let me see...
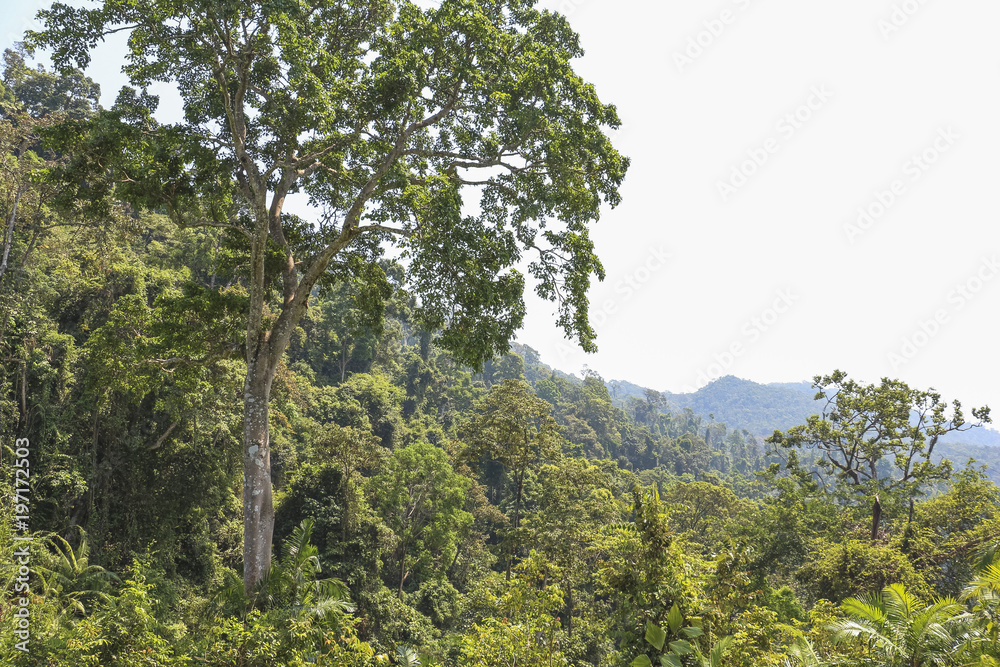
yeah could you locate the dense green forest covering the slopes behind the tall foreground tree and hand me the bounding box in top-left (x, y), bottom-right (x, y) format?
top-left (0, 3), bottom-right (1000, 667)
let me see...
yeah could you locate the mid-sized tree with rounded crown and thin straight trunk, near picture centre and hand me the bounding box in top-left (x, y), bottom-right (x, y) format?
top-left (465, 380), bottom-right (560, 580)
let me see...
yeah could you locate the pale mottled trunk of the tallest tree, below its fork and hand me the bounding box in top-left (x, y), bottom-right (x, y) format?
top-left (243, 360), bottom-right (274, 595)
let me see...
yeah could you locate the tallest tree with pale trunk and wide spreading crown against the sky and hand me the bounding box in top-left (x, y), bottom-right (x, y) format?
top-left (29, 0), bottom-right (628, 592)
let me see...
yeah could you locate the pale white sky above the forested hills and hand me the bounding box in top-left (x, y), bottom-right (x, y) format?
top-left (7, 0), bottom-right (1000, 421)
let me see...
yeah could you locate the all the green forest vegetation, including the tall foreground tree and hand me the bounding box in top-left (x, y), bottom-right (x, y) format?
top-left (0, 0), bottom-right (1000, 667)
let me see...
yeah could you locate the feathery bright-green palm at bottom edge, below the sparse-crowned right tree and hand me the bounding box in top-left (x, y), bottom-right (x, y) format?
top-left (830, 584), bottom-right (980, 667)
